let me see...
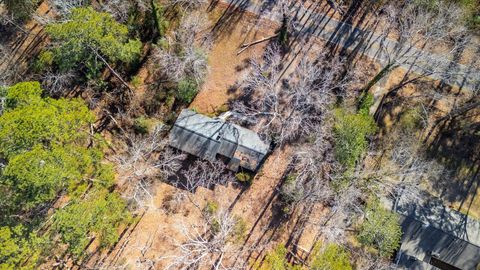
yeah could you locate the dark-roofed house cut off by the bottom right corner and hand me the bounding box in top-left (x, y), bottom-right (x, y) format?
top-left (396, 196), bottom-right (480, 270)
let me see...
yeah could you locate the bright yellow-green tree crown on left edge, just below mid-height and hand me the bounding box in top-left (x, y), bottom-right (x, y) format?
top-left (0, 144), bottom-right (101, 210)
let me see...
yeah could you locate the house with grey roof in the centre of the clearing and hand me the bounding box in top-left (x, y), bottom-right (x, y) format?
top-left (170, 109), bottom-right (270, 171)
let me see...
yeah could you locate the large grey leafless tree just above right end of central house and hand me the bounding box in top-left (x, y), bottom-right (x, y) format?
top-left (233, 46), bottom-right (346, 144)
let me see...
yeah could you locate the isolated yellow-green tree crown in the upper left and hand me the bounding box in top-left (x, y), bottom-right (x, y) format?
top-left (46, 7), bottom-right (141, 78)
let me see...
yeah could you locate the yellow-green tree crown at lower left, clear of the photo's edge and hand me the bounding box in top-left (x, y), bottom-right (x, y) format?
top-left (52, 191), bottom-right (132, 258)
